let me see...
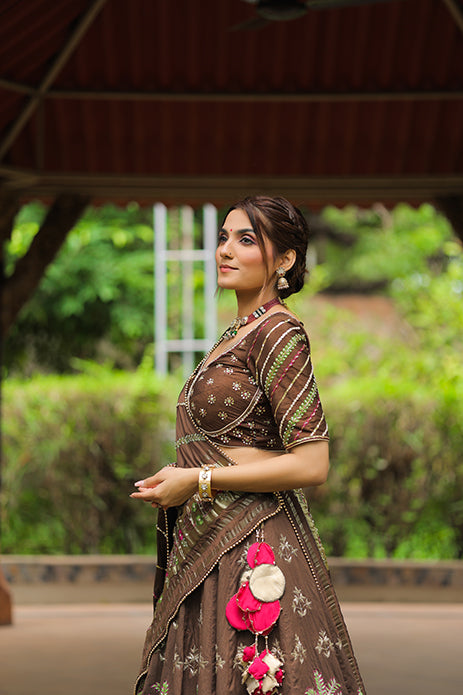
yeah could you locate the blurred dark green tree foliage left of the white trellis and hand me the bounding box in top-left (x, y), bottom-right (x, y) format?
top-left (5, 204), bottom-right (154, 373)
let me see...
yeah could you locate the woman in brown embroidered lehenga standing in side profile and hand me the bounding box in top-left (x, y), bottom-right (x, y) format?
top-left (132, 196), bottom-right (365, 695)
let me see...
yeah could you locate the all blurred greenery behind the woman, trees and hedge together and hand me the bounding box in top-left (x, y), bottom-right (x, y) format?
top-left (0, 203), bottom-right (463, 559)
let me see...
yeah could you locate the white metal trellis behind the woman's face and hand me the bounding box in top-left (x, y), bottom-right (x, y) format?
top-left (154, 203), bottom-right (217, 376)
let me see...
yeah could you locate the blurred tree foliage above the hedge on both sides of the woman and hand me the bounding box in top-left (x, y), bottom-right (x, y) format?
top-left (4, 198), bottom-right (462, 374)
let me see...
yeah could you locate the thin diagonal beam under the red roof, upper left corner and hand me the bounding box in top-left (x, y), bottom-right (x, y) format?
top-left (0, 0), bottom-right (106, 161)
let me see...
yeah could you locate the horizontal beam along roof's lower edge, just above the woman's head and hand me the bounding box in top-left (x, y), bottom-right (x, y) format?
top-left (0, 171), bottom-right (463, 204)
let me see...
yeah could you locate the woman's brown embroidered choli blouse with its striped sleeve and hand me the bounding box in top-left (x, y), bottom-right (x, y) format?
top-left (185, 312), bottom-right (328, 451)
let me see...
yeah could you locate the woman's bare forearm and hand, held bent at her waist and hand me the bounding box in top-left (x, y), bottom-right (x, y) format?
top-left (131, 441), bottom-right (329, 507)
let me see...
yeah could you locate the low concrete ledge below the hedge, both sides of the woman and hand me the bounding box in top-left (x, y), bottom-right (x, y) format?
top-left (0, 555), bottom-right (463, 603)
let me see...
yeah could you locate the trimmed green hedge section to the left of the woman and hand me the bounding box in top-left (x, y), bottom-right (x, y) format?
top-left (1, 366), bottom-right (177, 553)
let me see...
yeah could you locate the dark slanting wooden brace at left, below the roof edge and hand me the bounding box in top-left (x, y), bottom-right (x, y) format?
top-left (1, 193), bottom-right (90, 336)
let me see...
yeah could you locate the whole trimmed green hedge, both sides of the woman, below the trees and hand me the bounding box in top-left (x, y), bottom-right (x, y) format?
top-left (1, 367), bottom-right (463, 558)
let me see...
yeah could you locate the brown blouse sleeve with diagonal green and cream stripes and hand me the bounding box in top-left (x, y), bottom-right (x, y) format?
top-left (248, 312), bottom-right (329, 449)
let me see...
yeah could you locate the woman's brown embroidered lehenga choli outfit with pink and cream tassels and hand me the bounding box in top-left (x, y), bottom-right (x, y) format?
top-left (135, 311), bottom-right (366, 695)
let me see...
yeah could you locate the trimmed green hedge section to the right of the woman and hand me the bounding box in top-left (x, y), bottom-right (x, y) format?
top-left (309, 375), bottom-right (463, 559)
